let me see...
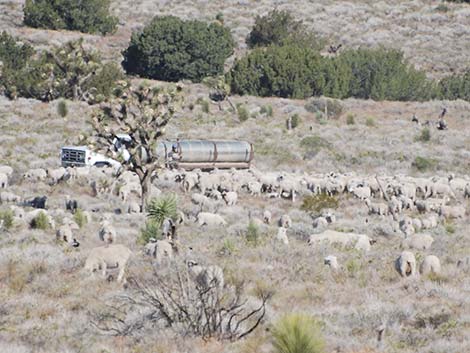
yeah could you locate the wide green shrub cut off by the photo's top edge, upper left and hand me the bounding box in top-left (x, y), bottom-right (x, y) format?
top-left (23, 0), bottom-right (118, 34)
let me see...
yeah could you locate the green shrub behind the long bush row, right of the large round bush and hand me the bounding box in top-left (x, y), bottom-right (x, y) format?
top-left (246, 9), bottom-right (325, 51)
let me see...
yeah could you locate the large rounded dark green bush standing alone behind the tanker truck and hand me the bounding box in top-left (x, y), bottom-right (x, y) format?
top-left (122, 16), bottom-right (234, 82)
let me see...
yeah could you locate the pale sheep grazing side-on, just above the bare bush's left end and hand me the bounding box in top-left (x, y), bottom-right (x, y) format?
top-left (85, 244), bottom-right (132, 282)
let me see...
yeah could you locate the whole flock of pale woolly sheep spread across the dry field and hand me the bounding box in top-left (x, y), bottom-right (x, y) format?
top-left (0, 161), bottom-right (470, 286)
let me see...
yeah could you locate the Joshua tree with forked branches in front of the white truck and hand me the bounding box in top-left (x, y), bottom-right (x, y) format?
top-left (91, 82), bottom-right (182, 212)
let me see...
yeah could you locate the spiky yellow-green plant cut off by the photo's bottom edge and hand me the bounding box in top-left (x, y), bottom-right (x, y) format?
top-left (272, 314), bottom-right (325, 353)
